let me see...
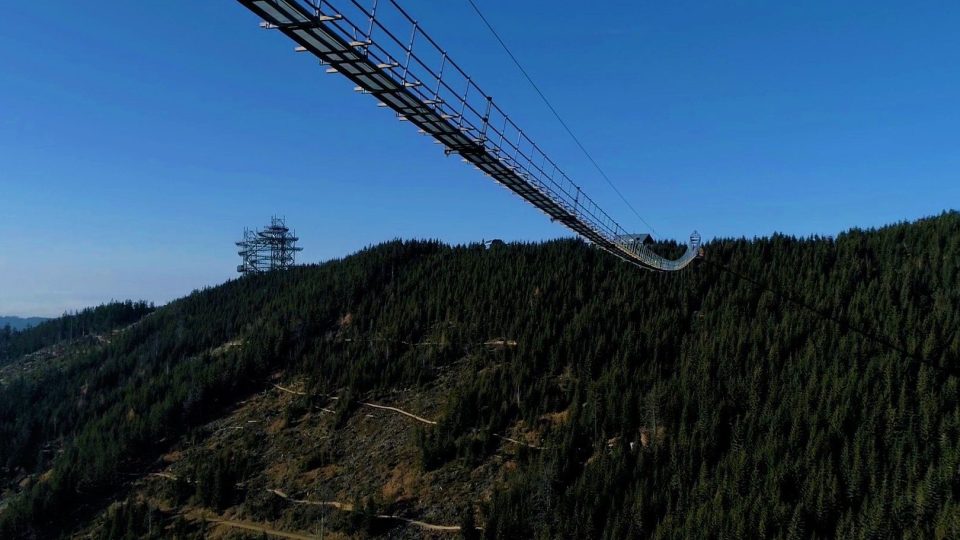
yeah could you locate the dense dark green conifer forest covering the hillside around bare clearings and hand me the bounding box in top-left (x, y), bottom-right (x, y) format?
top-left (0, 212), bottom-right (960, 539)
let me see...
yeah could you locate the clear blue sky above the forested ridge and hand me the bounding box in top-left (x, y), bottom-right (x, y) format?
top-left (0, 0), bottom-right (960, 315)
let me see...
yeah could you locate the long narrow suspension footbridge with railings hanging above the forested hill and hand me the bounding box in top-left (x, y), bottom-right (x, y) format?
top-left (238, 0), bottom-right (701, 271)
